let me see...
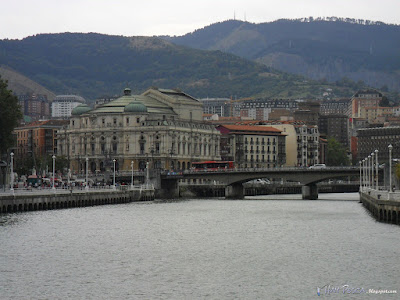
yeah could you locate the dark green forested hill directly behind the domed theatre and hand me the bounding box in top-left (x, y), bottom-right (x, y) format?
top-left (0, 33), bottom-right (364, 99)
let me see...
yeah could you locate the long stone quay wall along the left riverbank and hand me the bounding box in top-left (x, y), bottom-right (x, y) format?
top-left (0, 185), bottom-right (154, 213)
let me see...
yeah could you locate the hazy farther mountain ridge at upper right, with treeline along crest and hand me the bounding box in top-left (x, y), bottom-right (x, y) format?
top-left (164, 17), bottom-right (400, 91)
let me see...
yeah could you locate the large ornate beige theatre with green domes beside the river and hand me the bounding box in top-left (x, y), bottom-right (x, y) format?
top-left (58, 88), bottom-right (220, 173)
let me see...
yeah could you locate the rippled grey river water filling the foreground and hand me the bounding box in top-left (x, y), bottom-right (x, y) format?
top-left (0, 193), bottom-right (400, 299)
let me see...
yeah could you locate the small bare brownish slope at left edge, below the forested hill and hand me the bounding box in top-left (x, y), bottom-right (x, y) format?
top-left (0, 65), bottom-right (56, 101)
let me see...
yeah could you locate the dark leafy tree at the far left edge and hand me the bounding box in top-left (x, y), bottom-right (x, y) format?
top-left (0, 76), bottom-right (22, 155)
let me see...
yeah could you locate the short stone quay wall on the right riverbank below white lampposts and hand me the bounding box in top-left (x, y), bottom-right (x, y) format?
top-left (360, 188), bottom-right (400, 225)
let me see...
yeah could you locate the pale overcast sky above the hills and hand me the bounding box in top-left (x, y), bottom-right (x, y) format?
top-left (0, 0), bottom-right (400, 39)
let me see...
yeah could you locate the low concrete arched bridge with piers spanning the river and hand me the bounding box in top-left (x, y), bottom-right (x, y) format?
top-left (160, 167), bottom-right (360, 200)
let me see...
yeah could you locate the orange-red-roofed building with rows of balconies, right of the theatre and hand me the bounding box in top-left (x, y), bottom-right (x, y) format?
top-left (217, 125), bottom-right (286, 168)
